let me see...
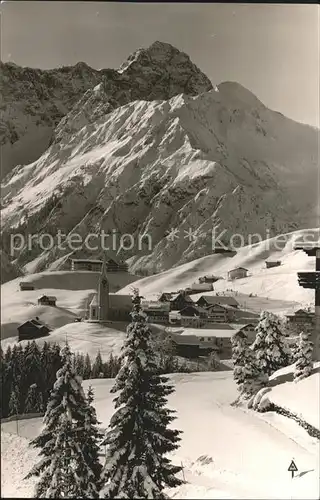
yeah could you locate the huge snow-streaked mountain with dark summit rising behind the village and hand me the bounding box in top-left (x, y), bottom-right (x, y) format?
top-left (2, 42), bottom-right (319, 278)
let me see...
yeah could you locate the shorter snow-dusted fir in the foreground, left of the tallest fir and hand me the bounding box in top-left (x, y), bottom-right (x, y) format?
top-left (26, 345), bottom-right (99, 498)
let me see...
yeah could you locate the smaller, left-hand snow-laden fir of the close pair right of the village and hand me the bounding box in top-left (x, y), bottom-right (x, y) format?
top-left (232, 331), bottom-right (268, 397)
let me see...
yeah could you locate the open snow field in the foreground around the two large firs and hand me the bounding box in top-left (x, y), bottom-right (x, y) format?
top-left (2, 372), bottom-right (319, 500)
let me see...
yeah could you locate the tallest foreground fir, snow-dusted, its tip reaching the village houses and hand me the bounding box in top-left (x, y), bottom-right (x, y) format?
top-left (100, 290), bottom-right (182, 499)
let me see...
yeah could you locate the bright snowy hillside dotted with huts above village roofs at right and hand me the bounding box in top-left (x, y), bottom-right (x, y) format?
top-left (119, 229), bottom-right (320, 311)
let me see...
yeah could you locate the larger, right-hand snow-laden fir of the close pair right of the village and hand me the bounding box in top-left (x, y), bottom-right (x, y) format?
top-left (252, 311), bottom-right (291, 375)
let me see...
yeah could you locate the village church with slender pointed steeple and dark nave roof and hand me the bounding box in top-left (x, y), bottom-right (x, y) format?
top-left (87, 256), bottom-right (132, 323)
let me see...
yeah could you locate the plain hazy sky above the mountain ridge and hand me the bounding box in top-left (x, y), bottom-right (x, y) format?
top-left (1, 1), bottom-right (319, 126)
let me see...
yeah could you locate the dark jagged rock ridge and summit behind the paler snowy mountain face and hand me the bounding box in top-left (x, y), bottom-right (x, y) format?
top-left (0, 42), bottom-right (212, 175)
